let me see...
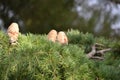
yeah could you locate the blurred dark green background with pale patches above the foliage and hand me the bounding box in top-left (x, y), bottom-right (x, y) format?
top-left (0, 0), bottom-right (120, 38)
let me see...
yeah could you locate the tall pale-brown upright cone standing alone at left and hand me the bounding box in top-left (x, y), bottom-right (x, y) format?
top-left (7, 23), bottom-right (19, 45)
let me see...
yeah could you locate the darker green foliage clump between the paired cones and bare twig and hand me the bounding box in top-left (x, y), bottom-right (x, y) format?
top-left (67, 30), bottom-right (95, 53)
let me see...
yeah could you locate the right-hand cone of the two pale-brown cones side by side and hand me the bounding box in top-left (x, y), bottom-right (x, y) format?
top-left (57, 31), bottom-right (68, 44)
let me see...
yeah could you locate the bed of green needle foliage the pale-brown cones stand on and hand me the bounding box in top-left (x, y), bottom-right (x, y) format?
top-left (0, 30), bottom-right (120, 80)
